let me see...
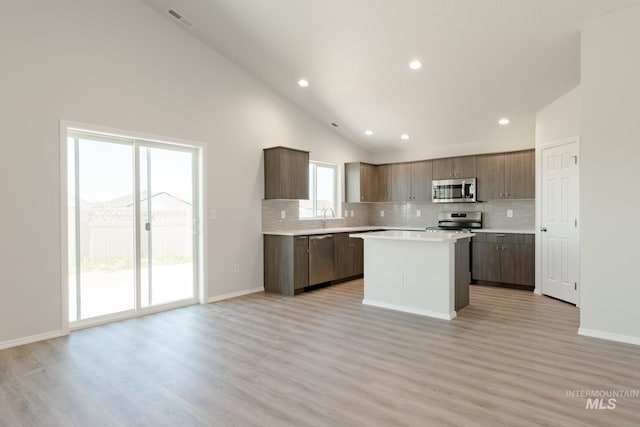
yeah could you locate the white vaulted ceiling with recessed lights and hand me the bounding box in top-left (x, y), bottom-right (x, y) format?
top-left (143, 0), bottom-right (640, 151)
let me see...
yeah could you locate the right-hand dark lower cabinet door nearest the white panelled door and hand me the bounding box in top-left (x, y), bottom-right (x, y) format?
top-left (500, 243), bottom-right (535, 286)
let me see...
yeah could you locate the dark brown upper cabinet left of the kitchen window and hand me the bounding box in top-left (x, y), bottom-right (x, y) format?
top-left (264, 147), bottom-right (309, 200)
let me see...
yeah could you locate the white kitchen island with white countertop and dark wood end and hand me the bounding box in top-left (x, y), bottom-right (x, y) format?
top-left (350, 230), bottom-right (475, 320)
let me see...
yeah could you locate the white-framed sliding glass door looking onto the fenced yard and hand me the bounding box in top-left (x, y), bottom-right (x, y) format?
top-left (67, 131), bottom-right (199, 327)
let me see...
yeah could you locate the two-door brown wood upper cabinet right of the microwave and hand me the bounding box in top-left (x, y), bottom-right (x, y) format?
top-left (476, 150), bottom-right (536, 201)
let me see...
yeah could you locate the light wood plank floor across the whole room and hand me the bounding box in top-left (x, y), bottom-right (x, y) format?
top-left (0, 280), bottom-right (640, 427)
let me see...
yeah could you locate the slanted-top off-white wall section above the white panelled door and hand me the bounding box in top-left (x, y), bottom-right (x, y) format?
top-left (536, 86), bottom-right (582, 147)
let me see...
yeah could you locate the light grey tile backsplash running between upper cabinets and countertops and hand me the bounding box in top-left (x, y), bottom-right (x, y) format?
top-left (262, 199), bottom-right (535, 231)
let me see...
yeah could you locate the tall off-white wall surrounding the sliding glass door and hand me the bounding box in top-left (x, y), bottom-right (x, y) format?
top-left (0, 0), bottom-right (367, 347)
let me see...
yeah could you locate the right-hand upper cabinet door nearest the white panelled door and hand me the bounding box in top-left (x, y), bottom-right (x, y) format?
top-left (504, 150), bottom-right (536, 199)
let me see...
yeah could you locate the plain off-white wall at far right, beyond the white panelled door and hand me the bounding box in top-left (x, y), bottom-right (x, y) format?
top-left (580, 2), bottom-right (640, 344)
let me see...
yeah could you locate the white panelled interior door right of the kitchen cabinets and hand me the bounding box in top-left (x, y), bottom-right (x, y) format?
top-left (540, 141), bottom-right (580, 304)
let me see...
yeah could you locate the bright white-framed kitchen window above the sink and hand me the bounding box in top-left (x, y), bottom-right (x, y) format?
top-left (299, 162), bottom-right (340, 218)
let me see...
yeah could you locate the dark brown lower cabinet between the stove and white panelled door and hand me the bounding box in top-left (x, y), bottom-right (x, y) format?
top-left (471, 233), bottom-right (535, 289)
